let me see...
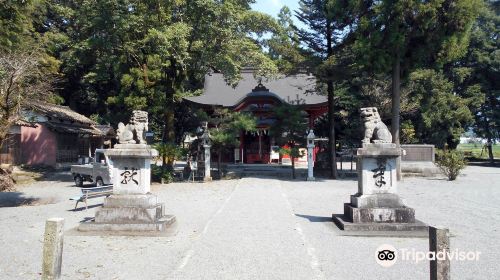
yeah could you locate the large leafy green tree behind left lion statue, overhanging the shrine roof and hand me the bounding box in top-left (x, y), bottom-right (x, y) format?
top-left (41, 0), bottom-right (277, 151)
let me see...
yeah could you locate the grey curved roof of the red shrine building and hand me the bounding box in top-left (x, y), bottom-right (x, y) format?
top-left (185, 70), bottom-right (328, 107)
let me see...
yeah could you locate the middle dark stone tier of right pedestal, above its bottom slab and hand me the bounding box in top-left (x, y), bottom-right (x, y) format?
top-left (344, 203), bottom-right (415, 223)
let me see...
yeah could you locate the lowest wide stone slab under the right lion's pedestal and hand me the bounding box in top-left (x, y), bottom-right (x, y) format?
top-left (332, 215), bottom-right (428, 237)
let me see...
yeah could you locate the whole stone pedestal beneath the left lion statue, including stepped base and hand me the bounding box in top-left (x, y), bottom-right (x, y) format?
top-left (78, 144), bottom-right (175, 232)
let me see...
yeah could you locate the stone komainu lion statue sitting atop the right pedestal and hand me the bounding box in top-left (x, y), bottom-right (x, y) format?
top-left (360, 107), bottom-right (392, 144)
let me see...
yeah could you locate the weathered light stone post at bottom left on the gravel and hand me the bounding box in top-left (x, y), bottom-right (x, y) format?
top-left (42, 218), bottom-right (64, 280)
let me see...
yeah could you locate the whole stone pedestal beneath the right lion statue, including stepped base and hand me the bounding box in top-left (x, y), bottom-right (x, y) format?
top-left (333, 143), bottom-right (427, 232)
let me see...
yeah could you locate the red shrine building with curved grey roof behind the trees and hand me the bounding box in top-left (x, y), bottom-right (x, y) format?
top-left (186, 70), bottom-right (328, 163)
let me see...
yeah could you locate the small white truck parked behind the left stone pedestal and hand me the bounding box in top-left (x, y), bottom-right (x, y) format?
top-left (71, 149), bottom-right (112, 188)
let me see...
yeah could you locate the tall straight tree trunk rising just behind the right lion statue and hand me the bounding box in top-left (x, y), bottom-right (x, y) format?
top-left (391, 53), bottom-right (401, 181)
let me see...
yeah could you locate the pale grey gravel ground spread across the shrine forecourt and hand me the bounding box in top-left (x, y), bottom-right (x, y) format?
top-left (0, 167), bottom-right (500, 279)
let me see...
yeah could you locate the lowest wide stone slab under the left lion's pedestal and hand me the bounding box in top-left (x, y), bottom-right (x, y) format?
top-left (78, 215), bottom-right (175, 233)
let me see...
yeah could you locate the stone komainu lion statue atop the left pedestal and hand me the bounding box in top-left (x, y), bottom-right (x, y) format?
top-left (116, 111), bottom-right (148, 144)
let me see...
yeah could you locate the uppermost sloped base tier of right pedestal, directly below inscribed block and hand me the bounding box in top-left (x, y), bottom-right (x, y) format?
top-left (351, 193), bottom-right (405, 208)
